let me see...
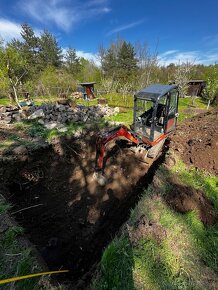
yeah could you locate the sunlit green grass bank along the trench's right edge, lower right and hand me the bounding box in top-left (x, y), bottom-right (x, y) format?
top-left (93, 161), bottom-right (218, 290)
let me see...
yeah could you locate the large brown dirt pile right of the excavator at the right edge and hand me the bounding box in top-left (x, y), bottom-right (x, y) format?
top-left (171, 109), bottom-right (218, 175)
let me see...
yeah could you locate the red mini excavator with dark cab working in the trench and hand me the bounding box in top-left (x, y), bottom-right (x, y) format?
top-left (94, 84), bottom-right (179, 185)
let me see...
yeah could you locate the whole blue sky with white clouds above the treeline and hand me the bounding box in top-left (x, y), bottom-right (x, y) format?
top-left (0, 0), bottom-right (218, 64)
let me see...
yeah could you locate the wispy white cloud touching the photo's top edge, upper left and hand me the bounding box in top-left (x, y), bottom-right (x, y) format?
top-left (19, 0), bottom-right (110, 31)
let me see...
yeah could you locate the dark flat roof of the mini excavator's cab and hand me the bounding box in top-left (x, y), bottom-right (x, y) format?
top-left (135, 84), bottom-right (177, 101)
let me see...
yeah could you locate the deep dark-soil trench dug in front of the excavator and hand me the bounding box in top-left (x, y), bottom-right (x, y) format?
top-left (0, 132), bottom-right (167, 289)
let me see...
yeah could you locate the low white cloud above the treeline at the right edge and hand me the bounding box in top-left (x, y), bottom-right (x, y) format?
top-left (158, 50), bottom-right (218, 66)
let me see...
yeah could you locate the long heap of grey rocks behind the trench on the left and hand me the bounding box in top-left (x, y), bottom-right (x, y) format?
top-left (0, 104), bottom-right (119, 126)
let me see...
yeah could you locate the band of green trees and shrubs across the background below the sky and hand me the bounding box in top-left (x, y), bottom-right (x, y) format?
top-left (0, 23), bottom-right (218, 103)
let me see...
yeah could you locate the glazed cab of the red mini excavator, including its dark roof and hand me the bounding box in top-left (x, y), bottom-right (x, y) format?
top-left (131, 84), bottom-right (179, 143)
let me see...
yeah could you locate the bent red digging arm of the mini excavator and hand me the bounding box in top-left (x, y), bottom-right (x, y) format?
top-left (95, 125), bottom-right (141, 172)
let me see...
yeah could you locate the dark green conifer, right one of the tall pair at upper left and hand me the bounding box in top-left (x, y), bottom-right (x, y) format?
top-left (39, 30), bottom-right (62, 69)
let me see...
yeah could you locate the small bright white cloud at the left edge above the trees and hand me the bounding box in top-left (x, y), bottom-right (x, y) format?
top-left (0, 18), bottom-right (21, 42)
